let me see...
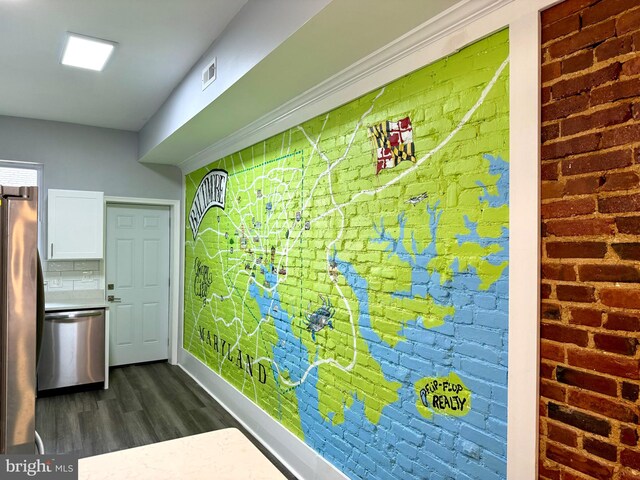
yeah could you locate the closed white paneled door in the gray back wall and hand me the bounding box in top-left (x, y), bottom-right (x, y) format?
top-left (106, 205), bottom-right (169, 366)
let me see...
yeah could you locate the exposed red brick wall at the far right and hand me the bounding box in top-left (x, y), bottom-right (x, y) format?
top-left (540, 0), bottom-right (640, 480)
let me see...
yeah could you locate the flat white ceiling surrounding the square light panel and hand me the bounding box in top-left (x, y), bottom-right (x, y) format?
top-left (0, 0), bottom-right (247, 131)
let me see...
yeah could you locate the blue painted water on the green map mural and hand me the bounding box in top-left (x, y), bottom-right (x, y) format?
top-left (250, 156), bottom-right (509, 480)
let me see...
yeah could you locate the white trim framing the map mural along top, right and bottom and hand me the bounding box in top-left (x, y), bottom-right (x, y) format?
top-left (180, 0), bottom-right (558, 480)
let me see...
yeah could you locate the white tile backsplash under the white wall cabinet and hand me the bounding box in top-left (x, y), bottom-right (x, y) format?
top-left (42, 260), bottom-right (104, 292)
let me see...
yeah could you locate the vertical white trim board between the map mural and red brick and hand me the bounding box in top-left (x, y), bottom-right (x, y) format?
top-left (507, 4), bottom-right (540, 479)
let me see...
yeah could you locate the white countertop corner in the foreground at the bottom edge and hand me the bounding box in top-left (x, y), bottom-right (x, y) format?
top-left (78, 428), bottom-right (285, 480)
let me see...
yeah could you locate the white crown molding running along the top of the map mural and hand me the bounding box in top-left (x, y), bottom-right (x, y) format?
top-left (177, 0), bottom-right (514, 174)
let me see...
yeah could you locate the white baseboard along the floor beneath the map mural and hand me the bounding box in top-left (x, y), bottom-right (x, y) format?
top-left (178, 348), bottom-right (348, 480)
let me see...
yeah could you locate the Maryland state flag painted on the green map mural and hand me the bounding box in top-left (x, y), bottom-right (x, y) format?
top-left (369, 117), bottom-right (416, 175)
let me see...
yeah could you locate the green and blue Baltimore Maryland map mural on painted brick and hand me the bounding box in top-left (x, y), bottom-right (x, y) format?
top-left (184, 30), bottom-right (509, 480)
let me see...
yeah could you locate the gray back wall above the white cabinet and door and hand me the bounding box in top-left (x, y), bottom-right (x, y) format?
top-left (0, 116), bottom-right (182, 200)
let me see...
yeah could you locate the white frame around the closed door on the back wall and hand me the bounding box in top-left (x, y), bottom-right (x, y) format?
top-left (104, 196), bottom-right (182, 365)
